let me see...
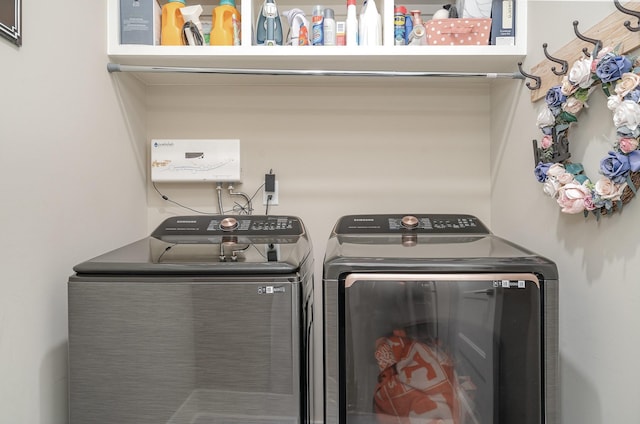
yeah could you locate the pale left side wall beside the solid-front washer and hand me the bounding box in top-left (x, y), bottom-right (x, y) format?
top-left (0, 1), bottom-right (147, 424)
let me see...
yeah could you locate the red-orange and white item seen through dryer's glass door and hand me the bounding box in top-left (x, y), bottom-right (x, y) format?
top-left (374, 330), bottom-right (459, 424)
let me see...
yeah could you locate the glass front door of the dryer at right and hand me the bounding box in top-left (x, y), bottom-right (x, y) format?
top-left (339, 274), bottom-right (543, 424)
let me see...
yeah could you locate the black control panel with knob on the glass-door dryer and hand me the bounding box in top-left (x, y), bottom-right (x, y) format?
top-left (335, 214), bottom-right (490, 235)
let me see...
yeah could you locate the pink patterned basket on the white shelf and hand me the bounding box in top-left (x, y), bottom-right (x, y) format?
top-left (424, 18), bottom-right (491, 46)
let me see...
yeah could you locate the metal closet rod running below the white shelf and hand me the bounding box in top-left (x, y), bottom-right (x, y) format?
top-left (107, 63), bottom-right (525, 80)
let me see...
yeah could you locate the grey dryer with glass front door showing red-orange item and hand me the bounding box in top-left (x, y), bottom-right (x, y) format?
top-left (323, 214), bottom-right (558, 424)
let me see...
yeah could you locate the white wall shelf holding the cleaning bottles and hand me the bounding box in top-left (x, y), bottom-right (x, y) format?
top-left (107, 0), bottom-right (527, 83)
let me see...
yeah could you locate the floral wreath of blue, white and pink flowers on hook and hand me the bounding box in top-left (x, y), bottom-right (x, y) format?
top-left (534, 46), bottom-right (640, 219)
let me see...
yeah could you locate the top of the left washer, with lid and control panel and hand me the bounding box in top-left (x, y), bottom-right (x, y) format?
top-left (74, 215), bottom-right (311, 275)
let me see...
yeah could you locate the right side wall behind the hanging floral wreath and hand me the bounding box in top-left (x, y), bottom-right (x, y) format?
top-left (491, 1), bottom-right (640, 424)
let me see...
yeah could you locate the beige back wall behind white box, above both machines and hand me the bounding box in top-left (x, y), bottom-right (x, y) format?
top-left (148, 81), bottom-right (490, 276)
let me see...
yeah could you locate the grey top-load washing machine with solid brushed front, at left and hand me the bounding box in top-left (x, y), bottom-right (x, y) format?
top-left (68, 215), bottom-right (313, 424)
